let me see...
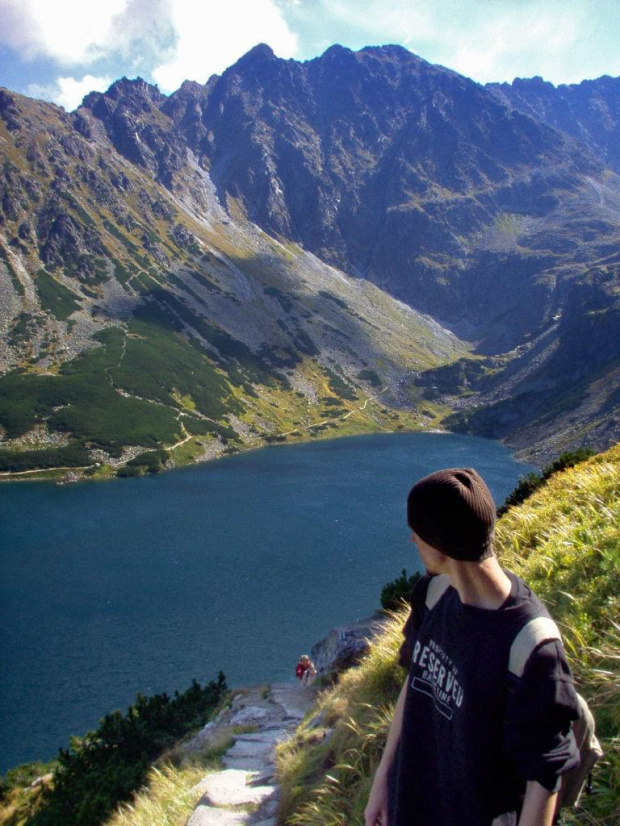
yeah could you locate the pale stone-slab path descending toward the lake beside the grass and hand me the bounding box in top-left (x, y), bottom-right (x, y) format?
top-left (187, 683), bottom-right (316, 826)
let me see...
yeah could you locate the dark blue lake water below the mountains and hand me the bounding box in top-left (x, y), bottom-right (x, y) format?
top-left (0, 434), bottom-right (530, 772)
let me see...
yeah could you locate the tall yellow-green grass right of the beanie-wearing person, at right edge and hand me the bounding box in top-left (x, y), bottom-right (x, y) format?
top-left (497, 446), bottom-right (620, 826)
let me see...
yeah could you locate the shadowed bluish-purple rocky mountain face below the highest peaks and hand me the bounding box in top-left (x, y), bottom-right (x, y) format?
top-left (164, 46), bottom-right (618, 334)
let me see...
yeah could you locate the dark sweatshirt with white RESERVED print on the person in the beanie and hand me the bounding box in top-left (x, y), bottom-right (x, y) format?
top-left (389, 572), bottom-right (579, 826)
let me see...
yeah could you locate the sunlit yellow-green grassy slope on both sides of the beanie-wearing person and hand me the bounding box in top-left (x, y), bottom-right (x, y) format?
top-left (280, 446), bottom-right (620, 826)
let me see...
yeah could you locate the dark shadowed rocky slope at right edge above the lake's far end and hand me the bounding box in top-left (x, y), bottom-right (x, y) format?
top-left (440, 256), bottom-right (620, 466)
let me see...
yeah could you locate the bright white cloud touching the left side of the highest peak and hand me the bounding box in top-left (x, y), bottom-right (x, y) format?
top-left (152, 0), bottom-right (297, 92)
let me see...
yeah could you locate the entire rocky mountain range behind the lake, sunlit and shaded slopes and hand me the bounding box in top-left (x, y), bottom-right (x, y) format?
top-left (0, 45), bottom-right (620, 475)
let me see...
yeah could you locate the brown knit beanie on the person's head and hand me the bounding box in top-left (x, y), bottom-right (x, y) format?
top-left (407, 468), bottom-right (495, 562)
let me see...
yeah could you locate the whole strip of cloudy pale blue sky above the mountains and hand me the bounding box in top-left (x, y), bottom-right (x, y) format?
top-left (0, 0), bottom-right (620, 111)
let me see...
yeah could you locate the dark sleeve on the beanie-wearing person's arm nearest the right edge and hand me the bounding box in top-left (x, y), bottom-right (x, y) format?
top-left (504, 641), bottom-right (579, 792)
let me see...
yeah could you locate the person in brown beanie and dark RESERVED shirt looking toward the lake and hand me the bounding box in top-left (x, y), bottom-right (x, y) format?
top-left (364, 468), bottom-right (579, 826)
